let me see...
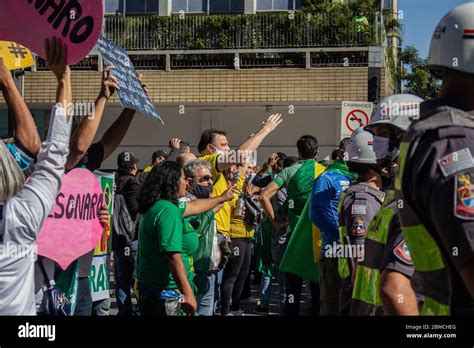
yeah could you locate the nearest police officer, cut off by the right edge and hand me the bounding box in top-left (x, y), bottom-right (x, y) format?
top-left (395, 2), bottom-right (474, 315)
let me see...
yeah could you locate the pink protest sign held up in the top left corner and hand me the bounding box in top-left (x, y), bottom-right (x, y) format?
top-left (0, 0), bottom-right (104, 64)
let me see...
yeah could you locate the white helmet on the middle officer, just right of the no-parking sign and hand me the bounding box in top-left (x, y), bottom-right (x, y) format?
top-left (365, 94), bottom-right (423, 131)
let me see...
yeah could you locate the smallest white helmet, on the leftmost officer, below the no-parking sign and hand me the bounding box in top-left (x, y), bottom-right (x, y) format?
top-left (347, 127), bottom-right (377, 164)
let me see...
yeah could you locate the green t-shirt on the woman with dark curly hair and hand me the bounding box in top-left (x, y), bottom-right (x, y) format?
top-left (137, 199), bottom-right (199, 289)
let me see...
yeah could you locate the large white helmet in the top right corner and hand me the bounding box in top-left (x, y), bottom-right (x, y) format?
top-left (428, 2), bottom-right (474, 77)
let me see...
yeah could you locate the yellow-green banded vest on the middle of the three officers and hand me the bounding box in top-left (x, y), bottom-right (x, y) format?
top-left (350, 190), bottom-right (398, 315)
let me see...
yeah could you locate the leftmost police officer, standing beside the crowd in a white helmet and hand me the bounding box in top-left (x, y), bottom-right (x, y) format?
top-left (338, 128), bottom-right (385, 314)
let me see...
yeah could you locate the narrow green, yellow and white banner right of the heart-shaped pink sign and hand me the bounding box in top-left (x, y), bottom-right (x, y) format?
top-left (89, 171), bottom-right (115, 301)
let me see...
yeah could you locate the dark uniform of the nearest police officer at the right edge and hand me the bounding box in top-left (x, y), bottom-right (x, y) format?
top-left (395, 100), bottom-right (474, 315)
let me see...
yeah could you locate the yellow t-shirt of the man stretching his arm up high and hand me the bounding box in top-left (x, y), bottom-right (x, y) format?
top-left (199, 153), bottom-right (230, 234)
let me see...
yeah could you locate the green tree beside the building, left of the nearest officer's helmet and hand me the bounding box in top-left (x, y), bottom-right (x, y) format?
top-left (399, 45), bottom-right (441, 100)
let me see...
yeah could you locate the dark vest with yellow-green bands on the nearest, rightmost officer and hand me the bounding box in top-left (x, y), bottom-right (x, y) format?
top-left (395, 109), bottom-right (474, 315)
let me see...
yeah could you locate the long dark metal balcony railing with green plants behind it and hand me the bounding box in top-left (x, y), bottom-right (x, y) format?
top-left (104, 11), bottom-right (380, 50)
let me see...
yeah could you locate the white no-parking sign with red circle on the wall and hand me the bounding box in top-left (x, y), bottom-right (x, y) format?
top-left (341, 101), bottom-right (374, 139)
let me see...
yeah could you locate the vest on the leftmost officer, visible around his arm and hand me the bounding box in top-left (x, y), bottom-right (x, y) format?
top-left (338, 184), bottom-right (385, 279)
